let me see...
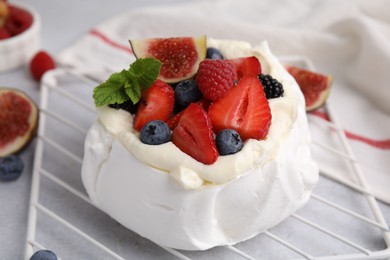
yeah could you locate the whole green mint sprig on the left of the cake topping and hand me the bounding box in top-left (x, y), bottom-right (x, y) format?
top-left (93, 58), bottom-right (161, 107)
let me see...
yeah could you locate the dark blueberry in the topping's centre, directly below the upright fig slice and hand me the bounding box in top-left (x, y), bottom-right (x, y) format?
top-left (175, 79), bottom-right (202, 107)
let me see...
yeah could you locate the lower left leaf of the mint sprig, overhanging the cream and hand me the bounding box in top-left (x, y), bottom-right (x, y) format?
top-left (93, 70), bottom-right (129, 107)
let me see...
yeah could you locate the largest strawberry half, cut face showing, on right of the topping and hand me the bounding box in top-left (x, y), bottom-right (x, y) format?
top-left (208, 75), bottom-right (271, 140)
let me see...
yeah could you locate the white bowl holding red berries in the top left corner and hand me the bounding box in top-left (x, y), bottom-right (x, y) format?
top-left (0, 3), bottom-right (41, 72)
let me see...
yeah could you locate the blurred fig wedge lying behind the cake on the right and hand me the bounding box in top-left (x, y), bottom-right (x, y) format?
top-left (285, 65), bottom-right (332, 112)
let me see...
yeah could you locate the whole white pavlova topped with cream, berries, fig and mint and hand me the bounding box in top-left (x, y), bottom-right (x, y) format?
top-left (82, 37), bottom-right (318, 250)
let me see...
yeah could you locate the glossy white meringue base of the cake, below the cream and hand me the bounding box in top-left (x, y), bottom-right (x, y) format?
top-left (82, 109), bottom-right (318, 250)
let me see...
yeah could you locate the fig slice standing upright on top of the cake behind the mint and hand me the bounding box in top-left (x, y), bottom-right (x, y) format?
top-left (129, 35), bottom-right (207, 83)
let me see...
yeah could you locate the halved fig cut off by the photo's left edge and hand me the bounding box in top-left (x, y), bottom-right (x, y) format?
top-left (0, 87), bottom-right (39, 157)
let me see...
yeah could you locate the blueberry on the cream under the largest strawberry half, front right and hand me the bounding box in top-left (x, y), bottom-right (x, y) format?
top-left (216, 129), bottom-right (243, 155)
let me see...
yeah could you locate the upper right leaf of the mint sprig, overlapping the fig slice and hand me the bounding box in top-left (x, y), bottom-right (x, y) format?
top-left (129, 58), bottom-right (161, 90)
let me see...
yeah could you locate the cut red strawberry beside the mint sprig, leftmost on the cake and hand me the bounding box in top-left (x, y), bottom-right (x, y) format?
top-left (134, 79), bottom-right (175, 131)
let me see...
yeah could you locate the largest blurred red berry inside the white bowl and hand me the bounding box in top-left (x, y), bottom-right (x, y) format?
top-left (5, 5), bottom-right (33, 35)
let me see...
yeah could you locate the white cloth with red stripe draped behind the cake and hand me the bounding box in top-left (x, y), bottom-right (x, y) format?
top-left (58, 0), bottom-right (390, 203)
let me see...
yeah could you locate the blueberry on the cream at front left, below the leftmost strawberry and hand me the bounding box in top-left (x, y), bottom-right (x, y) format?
top-left (140, 120), bottom-right (171, 145)
